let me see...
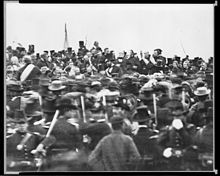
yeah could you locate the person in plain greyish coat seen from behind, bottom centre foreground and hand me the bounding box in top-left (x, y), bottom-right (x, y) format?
top-left (88, 116), bottom-right (140, 171)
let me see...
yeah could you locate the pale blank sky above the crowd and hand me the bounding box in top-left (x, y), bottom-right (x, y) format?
top-left (5, 2), bottom-right (214, 60)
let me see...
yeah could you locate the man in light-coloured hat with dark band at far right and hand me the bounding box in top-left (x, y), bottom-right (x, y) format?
top-left (187, 87), bottom-right (211, 127)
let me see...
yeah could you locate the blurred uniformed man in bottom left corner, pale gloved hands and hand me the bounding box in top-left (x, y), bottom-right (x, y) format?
top-left (6, 110), bottom-right (55, 172)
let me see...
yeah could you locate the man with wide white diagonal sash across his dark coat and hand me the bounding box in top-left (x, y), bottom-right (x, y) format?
top-left (16, 56), bottom-right (41, 82)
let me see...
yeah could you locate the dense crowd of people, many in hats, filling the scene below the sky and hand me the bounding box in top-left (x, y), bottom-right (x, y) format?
top-left (6, 41), bottom-right (214, 171)
